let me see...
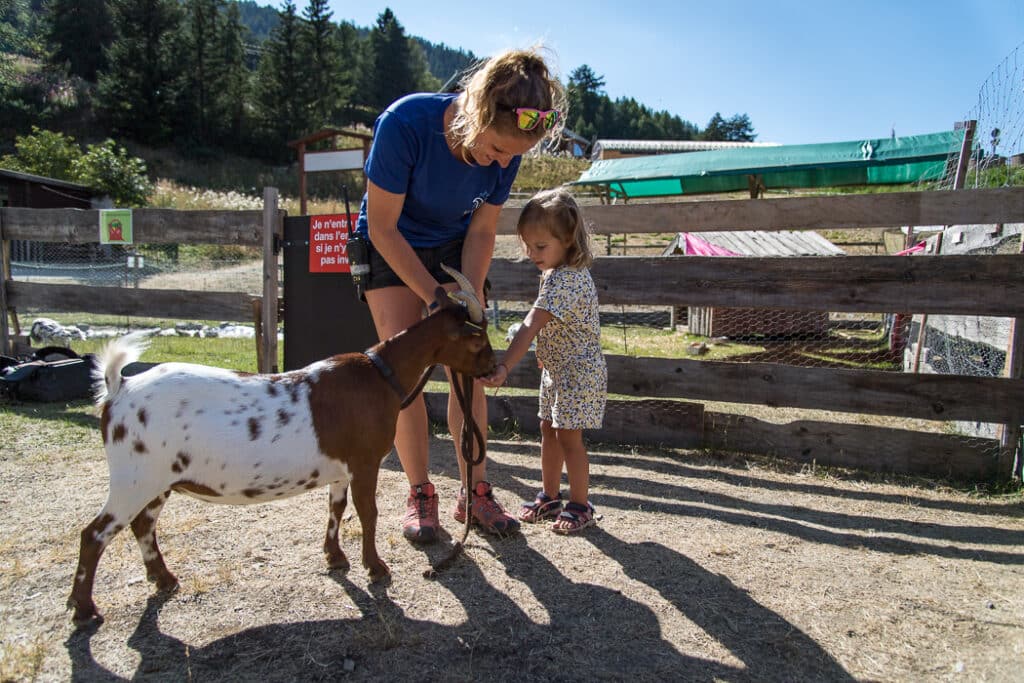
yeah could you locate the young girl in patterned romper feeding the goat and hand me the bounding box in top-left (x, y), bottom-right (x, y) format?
top-left (481, 189), bottom-right (608, 533)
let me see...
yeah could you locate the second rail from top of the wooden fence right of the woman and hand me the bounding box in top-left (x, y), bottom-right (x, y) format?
top-left (487, 254), bottom-right (1024, 317)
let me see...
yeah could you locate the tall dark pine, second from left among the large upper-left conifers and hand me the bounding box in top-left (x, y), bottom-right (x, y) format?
top-left (97, 0), bottom-right (184, 142)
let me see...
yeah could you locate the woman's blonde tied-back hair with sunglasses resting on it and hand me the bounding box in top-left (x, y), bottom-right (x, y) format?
top-left (451, 48), bottom-right (566, 147)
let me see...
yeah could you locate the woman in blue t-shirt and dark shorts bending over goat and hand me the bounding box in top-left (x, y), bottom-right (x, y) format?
top-left (357, 49), bottom-right (564, 543)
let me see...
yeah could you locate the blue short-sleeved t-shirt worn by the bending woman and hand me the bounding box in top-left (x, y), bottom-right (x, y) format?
top-left (356, 93), bottom-right (521, 247)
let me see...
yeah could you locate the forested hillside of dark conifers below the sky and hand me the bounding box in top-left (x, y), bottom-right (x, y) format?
top-left (0, 0), bottom-right (756, 169)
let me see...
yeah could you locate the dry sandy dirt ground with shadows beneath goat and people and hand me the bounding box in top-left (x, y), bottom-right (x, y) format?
top-left (0, 428), bottom-right (1024, 682)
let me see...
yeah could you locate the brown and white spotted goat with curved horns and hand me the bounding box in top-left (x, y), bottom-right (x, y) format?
top-left (68, 278), bottom-right (495, 625)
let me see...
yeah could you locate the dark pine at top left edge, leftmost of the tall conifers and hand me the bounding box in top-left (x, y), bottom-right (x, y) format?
top-left (45, 0), bottom-right (114, 83)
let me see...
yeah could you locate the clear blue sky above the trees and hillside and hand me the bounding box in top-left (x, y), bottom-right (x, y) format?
top-left (329, 0), bottom-right (1024, 144)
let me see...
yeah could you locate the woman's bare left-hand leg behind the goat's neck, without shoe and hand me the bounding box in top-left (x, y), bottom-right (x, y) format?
top-left (367, 287), bottom-right (430, 486)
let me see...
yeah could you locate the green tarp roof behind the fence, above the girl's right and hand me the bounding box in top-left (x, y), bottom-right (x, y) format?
top-left (570, 130), bottom-right (964, 198)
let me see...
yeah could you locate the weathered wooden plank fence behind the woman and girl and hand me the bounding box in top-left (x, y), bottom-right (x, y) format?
top-left (0, 188), bottom-right (1024, 479)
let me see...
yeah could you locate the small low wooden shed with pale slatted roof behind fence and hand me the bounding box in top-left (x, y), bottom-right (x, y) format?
top-left (663, 230), bottom-right (845, 338)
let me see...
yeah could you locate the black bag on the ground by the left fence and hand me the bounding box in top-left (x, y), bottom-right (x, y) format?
top-left (0, 347), bottom-right (95, 401)
